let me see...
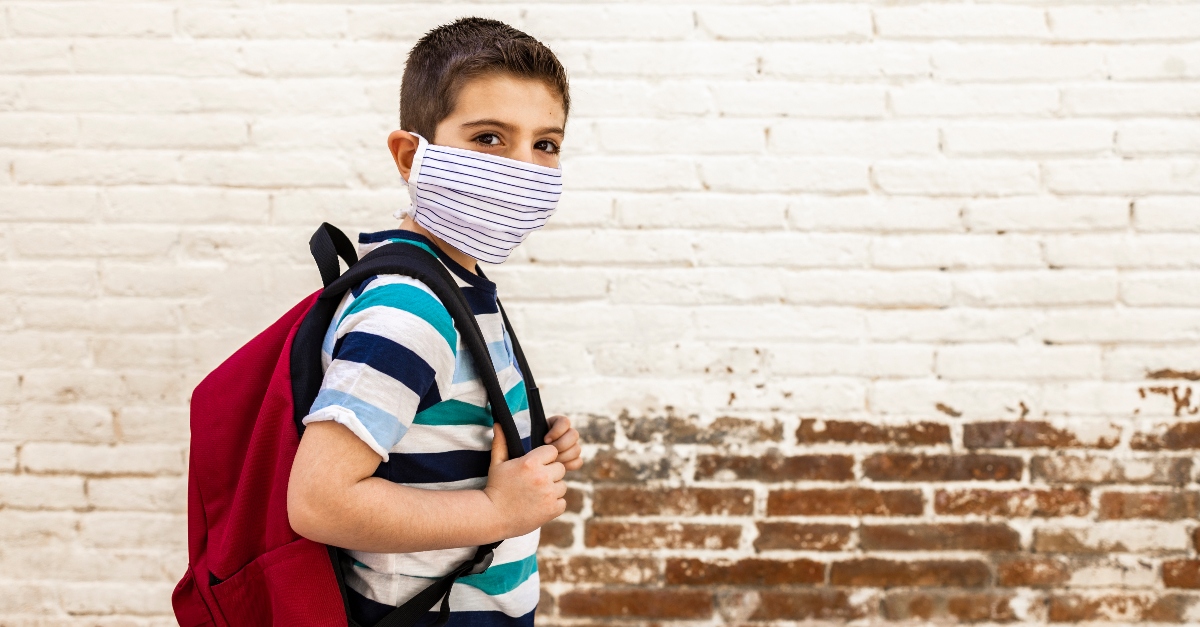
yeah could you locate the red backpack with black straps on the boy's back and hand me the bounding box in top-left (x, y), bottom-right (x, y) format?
top-left (172, 223), bottom-right (547, 627)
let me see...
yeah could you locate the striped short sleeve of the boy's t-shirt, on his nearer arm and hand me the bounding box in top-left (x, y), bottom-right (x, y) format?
top-left (302, 275), bottom-right (458, 461)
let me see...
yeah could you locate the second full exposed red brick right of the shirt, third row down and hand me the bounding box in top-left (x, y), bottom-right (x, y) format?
top-left (767, 488), bottom-right (925, 516)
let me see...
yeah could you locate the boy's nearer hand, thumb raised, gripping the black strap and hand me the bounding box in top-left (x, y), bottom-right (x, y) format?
top-left (484, 424), bottom-right (566, 538)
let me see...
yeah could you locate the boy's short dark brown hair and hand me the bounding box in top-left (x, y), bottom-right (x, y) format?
top-left (400, 17), bottom-right (571, 142)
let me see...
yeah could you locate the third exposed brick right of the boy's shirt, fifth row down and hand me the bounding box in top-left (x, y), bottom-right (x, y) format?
top-left (829, 559), bottom-right (989, 587)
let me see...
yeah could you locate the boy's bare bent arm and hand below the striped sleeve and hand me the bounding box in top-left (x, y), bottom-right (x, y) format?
top-left (288, 422), bottom-right (566, 553)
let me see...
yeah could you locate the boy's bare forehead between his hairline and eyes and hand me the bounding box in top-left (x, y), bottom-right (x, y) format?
top-left (443, 73), bottom-right (566, 132)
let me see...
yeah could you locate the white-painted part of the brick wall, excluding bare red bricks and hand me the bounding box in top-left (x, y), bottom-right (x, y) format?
top-left (0, 0), bottom-right (1200, 627)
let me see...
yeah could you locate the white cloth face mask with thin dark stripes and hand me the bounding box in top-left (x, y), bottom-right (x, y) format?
top-left (397, 133), bottom-right (563, 263)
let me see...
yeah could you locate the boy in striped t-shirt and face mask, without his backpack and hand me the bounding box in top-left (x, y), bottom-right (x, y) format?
top-left (288, 18), bottom-right (582, 626)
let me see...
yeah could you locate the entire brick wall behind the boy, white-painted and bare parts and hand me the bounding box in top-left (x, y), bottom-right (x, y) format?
top-left (0, 0), bottom-right (1200, 627)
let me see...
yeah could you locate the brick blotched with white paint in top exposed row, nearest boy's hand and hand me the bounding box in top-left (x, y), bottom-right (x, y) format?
top-left (620, 414), bottom-right (784, 444)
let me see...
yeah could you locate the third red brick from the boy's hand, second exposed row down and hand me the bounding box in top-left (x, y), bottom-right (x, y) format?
top-left (863, 453), bottom-right (1022, 482)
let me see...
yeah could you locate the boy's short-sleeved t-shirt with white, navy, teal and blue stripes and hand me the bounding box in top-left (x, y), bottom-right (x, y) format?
top-left (304, 231), bottom-right (539, 627)
